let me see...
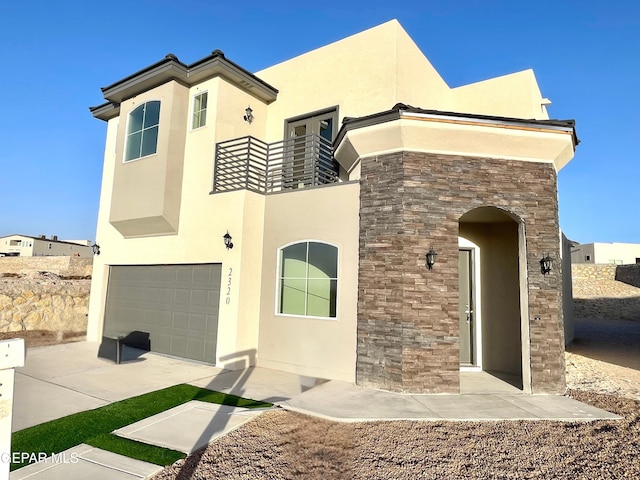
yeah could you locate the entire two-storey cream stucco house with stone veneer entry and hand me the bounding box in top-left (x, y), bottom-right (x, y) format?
top-left (88, 21), bottom-right (577, 393)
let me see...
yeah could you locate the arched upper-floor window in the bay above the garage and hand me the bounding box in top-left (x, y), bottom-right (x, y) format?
top-left (124, 100), bottom-right (160, 162)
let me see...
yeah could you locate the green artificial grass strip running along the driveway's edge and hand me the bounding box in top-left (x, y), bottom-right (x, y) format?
top-left (11, 383), bottom-right (272, 470)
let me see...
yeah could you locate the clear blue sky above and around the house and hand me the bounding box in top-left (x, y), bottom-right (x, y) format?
top-left (0, 0), bottom-right (640, 243)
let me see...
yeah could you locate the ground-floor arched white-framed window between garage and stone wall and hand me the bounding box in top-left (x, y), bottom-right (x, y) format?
top-left (278, 241), bottom-right (338, 318)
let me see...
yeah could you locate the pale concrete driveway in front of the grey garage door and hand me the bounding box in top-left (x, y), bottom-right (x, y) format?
top-left (12, 342), bottom-right (306, 432)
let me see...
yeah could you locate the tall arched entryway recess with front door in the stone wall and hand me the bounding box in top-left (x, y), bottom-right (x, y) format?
top-left (459, 207), bottom-right (530, 393)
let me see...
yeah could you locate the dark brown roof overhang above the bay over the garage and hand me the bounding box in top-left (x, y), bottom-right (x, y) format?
top-left (89, 50), bottom-right (278, 120)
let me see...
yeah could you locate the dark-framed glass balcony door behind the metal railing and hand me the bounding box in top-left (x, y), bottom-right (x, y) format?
top-left (283, 109), bottom-right (338, 188)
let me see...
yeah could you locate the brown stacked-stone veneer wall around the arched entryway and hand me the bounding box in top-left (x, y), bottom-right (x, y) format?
top-left (356, 152), bottom-right (565, 393)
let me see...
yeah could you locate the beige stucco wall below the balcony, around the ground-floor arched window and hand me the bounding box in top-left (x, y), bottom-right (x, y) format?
top-left (258, 183), bottom-right (359, 382)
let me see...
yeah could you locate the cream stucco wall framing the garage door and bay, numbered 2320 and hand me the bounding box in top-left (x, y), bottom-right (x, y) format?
top-left (87, 79), bottom-right (264, 366)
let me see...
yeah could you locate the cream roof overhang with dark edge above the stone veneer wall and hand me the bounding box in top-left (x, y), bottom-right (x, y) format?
top-left (335, 105), bottom-right (579, 171)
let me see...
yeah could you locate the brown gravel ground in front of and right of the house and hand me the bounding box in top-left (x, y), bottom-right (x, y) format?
top-left (154, 316), bottom-right (640, 480)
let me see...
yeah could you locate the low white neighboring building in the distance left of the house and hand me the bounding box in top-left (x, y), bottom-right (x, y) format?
top-left (0, 235), bottom-right (93, 257)
